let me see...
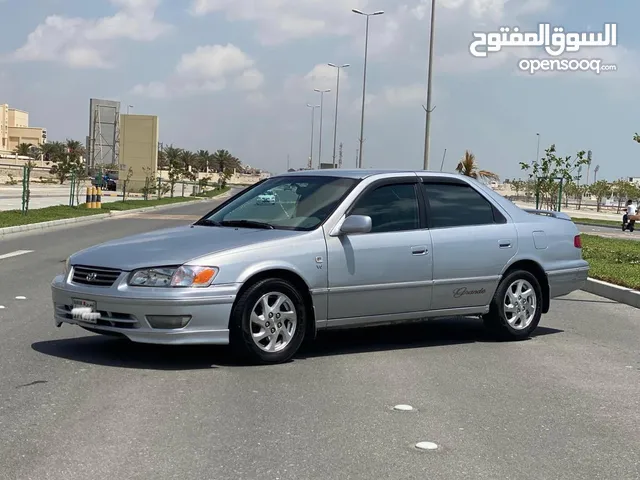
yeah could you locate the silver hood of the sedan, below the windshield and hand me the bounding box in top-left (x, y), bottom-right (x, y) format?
top-left (71, 225), bottom-right (305, 271)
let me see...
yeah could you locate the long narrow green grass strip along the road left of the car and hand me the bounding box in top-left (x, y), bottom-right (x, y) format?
top-left (0, 197), bottom-right (195, 228)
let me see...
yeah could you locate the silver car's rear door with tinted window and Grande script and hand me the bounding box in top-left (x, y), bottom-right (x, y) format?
top-left (422, 177), bottom-right (518, 310)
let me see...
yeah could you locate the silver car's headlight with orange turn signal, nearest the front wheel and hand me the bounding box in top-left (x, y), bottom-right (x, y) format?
top-left (129, 265), bottom-right (218, 287)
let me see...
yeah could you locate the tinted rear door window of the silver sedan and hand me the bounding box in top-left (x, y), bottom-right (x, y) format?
top-left (424, 183), bottom-right (494, 228)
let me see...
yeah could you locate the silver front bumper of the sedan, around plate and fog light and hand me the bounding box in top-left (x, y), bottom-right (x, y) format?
top-left (51, 275), bottom-right (240, 345)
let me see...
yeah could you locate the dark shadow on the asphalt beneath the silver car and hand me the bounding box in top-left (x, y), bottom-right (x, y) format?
top-left (31, 318), bottom-right (562, 371)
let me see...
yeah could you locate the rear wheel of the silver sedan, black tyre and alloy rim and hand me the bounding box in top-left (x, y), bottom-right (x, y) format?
top-left (483, 270), bottom-right (543, 340)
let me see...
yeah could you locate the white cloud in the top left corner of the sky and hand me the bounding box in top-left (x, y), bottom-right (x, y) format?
top-left (11, 0), bottom-right (171, 68)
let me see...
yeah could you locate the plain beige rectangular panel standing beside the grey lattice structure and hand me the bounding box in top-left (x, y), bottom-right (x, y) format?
top-left (118, 115), bottom-right (158, 192)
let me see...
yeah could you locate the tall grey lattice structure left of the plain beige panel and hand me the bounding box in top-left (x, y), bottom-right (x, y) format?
top-left (86, 98), bottom-right (120, 173)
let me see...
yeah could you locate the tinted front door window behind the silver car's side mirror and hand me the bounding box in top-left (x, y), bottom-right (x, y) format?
top-left (350, 184), bottom-right (420, 233)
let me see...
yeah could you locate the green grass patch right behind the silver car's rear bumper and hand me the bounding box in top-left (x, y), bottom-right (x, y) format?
top-left (581, 234), bottom-right (640, 290)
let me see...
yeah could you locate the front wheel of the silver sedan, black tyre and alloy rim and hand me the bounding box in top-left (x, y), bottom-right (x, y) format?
top-left (229, 278), bottom-right (307, 364)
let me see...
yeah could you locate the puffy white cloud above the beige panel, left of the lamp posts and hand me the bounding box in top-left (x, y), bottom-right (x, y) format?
top-left (132, 44), bottom-right (264, 98)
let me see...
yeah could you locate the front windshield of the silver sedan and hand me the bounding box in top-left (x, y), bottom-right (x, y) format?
top-left (197, 175), bottom-right (357, 230)
